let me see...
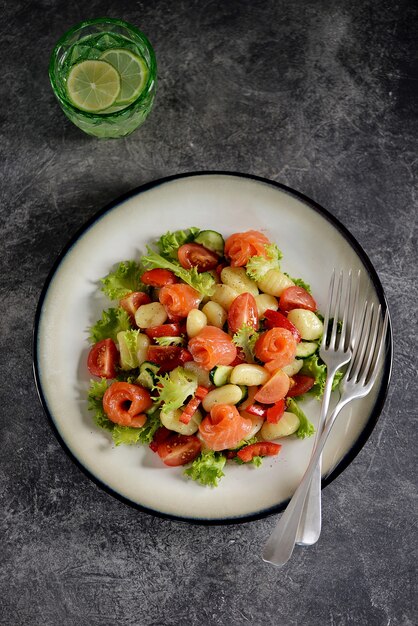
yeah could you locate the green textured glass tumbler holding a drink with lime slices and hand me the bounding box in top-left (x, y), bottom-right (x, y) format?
top-left (49, 17), bottom-right (157, 138)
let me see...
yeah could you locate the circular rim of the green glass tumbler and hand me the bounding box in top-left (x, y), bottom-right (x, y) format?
top-left (48, 17), bottom-right (157, 120)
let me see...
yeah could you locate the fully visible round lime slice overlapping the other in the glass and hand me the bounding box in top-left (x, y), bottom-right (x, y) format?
top-left (67, 61), bottom-right (121, 113)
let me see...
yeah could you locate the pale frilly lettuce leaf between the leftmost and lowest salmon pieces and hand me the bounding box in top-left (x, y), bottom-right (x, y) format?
top-left (153, 367), bottom-right (197, 415)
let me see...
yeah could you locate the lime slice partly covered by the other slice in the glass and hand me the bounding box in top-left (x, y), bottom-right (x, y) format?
top-left (100, 48), bottom-right (148, 105)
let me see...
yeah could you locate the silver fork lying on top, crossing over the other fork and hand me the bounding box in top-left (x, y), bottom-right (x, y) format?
top-left (263, 301), bottom-right (389, 567)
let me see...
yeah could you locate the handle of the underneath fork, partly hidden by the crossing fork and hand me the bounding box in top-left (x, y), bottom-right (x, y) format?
top-left (296, 368), bottom-right (337, 546)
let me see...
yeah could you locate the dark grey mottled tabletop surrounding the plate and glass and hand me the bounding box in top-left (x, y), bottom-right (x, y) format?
top-left (0, 0), bottom-right (418, 626)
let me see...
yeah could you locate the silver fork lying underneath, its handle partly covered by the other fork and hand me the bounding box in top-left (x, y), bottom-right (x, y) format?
top-left (296, 269), bottom-right (360, 545)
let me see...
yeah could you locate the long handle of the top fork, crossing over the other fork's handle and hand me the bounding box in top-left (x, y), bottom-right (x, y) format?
top-left (263, 400), bottom-right (349, 567)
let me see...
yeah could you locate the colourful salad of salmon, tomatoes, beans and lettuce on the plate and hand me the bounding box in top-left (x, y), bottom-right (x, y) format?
top-left (87, 227), bottom-right (340, 486)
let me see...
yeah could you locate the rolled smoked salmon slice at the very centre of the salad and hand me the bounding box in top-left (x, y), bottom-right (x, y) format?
top-left (188, 326), bottom-right (237, 370)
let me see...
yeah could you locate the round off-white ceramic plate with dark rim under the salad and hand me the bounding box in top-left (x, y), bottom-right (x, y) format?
top-left (34, 172), bottom-right (392, 523)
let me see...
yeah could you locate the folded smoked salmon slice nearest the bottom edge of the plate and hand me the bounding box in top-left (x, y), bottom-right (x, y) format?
top-left (199, 404), bottom-right (252, 452)
